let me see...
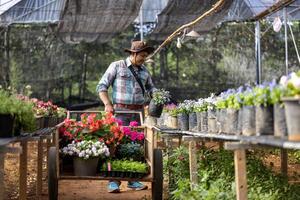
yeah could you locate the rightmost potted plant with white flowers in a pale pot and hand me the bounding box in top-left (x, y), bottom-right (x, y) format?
top-left (281, 71), bottom-right (300, 141)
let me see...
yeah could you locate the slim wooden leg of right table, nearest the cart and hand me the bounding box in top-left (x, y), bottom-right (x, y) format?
top-left (189, 141), bottom-right (198, 189)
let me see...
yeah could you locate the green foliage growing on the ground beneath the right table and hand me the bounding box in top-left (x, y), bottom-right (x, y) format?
top-left (165, 147), bottom-right (300, 200)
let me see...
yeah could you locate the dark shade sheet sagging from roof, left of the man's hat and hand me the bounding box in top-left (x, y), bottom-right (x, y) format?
top-left (58, 0), bottom-right (142, 43)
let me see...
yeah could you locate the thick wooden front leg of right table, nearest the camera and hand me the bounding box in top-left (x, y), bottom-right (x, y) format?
top-left (234, 149), bottom-right (247, 200)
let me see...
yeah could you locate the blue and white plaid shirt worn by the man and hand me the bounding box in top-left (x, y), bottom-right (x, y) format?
top-left (96, 57), bottom-right (155, 105)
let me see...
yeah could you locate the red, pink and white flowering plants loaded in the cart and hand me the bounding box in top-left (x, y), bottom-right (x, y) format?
top-left (59, 113), bottom-right (145, 176)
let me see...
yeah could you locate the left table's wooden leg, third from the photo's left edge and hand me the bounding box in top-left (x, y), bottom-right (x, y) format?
top-left (36, 137), bottom-right (43, 199)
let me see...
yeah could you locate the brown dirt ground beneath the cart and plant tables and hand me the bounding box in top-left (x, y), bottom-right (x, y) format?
top-left (4, 142), bottom-right (300, 200)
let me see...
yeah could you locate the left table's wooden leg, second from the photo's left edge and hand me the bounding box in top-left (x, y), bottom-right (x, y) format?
top-left (19, 141), bottom-right (27, 200)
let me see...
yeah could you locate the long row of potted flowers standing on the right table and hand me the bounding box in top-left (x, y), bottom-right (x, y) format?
top-left (158, 72), bottom-right (300, 140)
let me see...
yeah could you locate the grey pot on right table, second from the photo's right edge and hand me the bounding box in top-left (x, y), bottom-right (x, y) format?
top-left (274, 104), bottom-right (287, 138)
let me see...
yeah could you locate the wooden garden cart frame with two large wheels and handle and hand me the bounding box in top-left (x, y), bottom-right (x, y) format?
top-left (48, 111), bottom-right (163, 200)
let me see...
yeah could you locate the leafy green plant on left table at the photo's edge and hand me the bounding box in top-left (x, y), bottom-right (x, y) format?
top-left (0, 89), bottom-right (35, 131)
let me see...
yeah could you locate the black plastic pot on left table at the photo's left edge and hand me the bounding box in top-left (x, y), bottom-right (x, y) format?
top-left (0, 114), bottom-right (15, 138)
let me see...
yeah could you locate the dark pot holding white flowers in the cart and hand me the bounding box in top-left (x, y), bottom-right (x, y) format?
top-left (73, 157), bottom-right (99, 176)
